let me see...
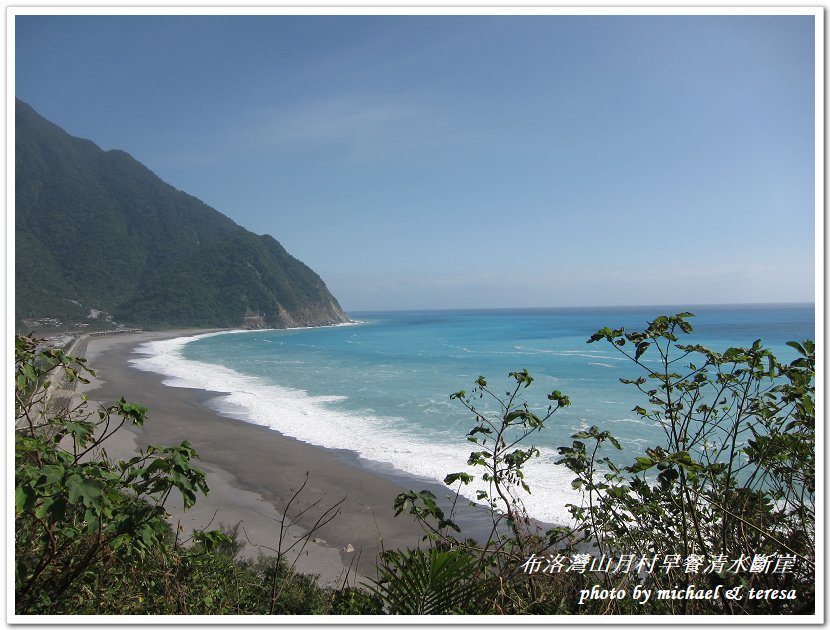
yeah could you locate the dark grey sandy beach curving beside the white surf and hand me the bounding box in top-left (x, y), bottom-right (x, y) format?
top-left (75, 331), bottom-right (432, 586)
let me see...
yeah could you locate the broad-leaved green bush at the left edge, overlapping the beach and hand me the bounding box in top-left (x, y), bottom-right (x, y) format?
top-left (15, 337), bottom-right (214, 612)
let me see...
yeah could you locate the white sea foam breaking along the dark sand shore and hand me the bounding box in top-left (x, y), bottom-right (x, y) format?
top-left (130, 331), bottom-right (580, 524)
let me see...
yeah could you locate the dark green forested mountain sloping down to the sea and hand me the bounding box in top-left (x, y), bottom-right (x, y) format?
top-left (15, 100), bottom-right (348, 327)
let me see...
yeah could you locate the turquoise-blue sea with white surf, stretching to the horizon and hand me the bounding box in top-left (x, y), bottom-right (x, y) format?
top-left (134, 305), bottom-right (815, 522)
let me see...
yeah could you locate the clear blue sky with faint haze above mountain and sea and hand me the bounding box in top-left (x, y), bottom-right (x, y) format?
top-left (14, 15), bottom-right (816, 311)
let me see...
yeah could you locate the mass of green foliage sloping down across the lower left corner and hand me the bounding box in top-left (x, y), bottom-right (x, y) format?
top-left (14, 336), bottom-right (356, 615)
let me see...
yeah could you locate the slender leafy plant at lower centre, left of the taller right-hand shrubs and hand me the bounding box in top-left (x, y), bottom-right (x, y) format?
top-left (392, 370), bottom-right (570, 613)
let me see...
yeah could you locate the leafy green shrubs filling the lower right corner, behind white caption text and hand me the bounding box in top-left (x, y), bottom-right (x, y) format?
top-left (388, 313), bottom-right (816, 614)
